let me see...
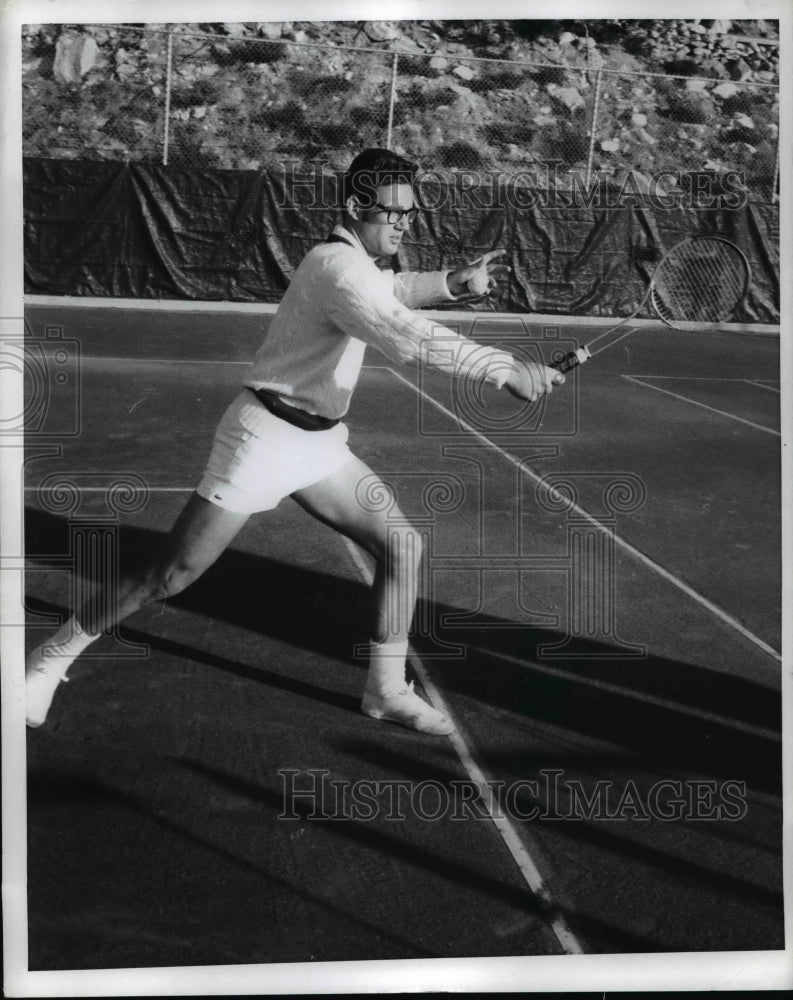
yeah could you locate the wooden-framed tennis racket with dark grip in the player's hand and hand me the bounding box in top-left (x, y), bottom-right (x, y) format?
top-left (550, 236), bottom-right (751, 372)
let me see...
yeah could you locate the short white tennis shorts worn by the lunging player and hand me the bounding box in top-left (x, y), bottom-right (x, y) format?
top-left (196, 389), bottom-right (353, 514)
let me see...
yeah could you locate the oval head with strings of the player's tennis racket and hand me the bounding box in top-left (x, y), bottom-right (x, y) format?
top-left (653, 239), bottom-right (748, 324)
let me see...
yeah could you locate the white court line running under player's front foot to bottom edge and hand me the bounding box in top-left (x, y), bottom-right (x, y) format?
top-left (342, 535), bottom-right (584, 955)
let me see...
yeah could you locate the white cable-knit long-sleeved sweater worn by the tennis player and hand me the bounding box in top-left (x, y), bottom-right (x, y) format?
top-left (245, 226), bottom-right (512, 418)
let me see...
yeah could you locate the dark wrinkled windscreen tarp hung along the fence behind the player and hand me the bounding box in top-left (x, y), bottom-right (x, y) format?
top-left (24, 158), bottom-right (779, 323)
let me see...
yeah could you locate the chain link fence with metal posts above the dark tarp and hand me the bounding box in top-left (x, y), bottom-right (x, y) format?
top-left (23, 25), bottom-right (779, 202)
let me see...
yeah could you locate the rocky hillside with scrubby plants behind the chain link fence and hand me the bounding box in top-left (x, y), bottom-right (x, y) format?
top-left (23, 20), bottom-right (778, 195)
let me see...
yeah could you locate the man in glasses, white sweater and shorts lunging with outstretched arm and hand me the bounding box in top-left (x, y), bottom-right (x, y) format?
top-left (25, 149), bottom-right (563, 735)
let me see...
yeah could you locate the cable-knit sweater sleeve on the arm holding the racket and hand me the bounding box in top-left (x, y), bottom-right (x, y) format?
top-left (326, 258), bottom-right (513, 388)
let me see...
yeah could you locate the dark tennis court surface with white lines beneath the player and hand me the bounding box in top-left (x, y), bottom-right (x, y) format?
top-left (25, 303), bottom-right (784, 970)
